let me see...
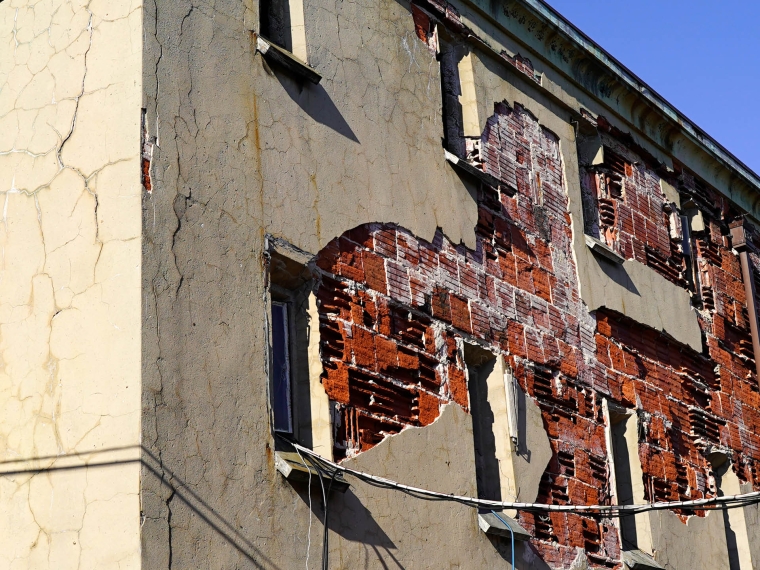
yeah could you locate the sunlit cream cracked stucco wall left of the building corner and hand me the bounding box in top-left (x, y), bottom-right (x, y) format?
top-left (0, 0), bottom-right (142, 569)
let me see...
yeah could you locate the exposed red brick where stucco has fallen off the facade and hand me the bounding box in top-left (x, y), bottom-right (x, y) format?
top-left (308, 104), bottom-right (760, 568)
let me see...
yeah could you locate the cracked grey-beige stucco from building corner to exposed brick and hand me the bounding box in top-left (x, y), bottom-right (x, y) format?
top-left (141, 0), bottom-right (510, 569)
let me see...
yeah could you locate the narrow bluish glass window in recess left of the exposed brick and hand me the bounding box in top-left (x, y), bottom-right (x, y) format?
top-left (272, 302), bottom-right (293, 434)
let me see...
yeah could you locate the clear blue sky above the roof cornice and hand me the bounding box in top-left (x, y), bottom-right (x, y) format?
top-left (547, 0), bottom-right (760, 174)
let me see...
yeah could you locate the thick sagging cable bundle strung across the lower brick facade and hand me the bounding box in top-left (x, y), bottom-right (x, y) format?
top-left (292, 443), bottom-right (760, 518)
